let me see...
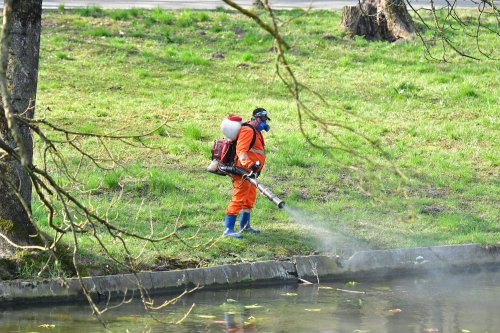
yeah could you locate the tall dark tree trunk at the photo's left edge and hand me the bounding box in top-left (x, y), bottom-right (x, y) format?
top-left (0, 0), bottom-right (42, 258)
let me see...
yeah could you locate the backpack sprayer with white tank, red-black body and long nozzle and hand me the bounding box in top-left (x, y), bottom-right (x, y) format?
top-left (207, 117), bottom-right (285, 208)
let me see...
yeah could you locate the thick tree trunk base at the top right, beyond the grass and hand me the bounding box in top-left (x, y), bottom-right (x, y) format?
top-left (342, 0), bottom-right (415, 42)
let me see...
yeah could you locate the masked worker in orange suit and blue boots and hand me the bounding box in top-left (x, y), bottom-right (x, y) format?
top-left (224, 108), bottom-right (271, 238)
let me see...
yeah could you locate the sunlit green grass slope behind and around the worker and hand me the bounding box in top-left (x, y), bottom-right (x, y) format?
top-left (28, 7), bottom-right (500, 273)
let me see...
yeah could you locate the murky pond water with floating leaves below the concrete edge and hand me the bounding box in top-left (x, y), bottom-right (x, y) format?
top-left (0, 271), bottom-right (500, 333)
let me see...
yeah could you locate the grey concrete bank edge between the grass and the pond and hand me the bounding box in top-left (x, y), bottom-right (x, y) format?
top-left (0, 244), bottom-right (500, 305)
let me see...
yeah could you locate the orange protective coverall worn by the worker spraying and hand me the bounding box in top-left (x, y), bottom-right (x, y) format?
top-left (226, 122), bottom-right (266, 215)
